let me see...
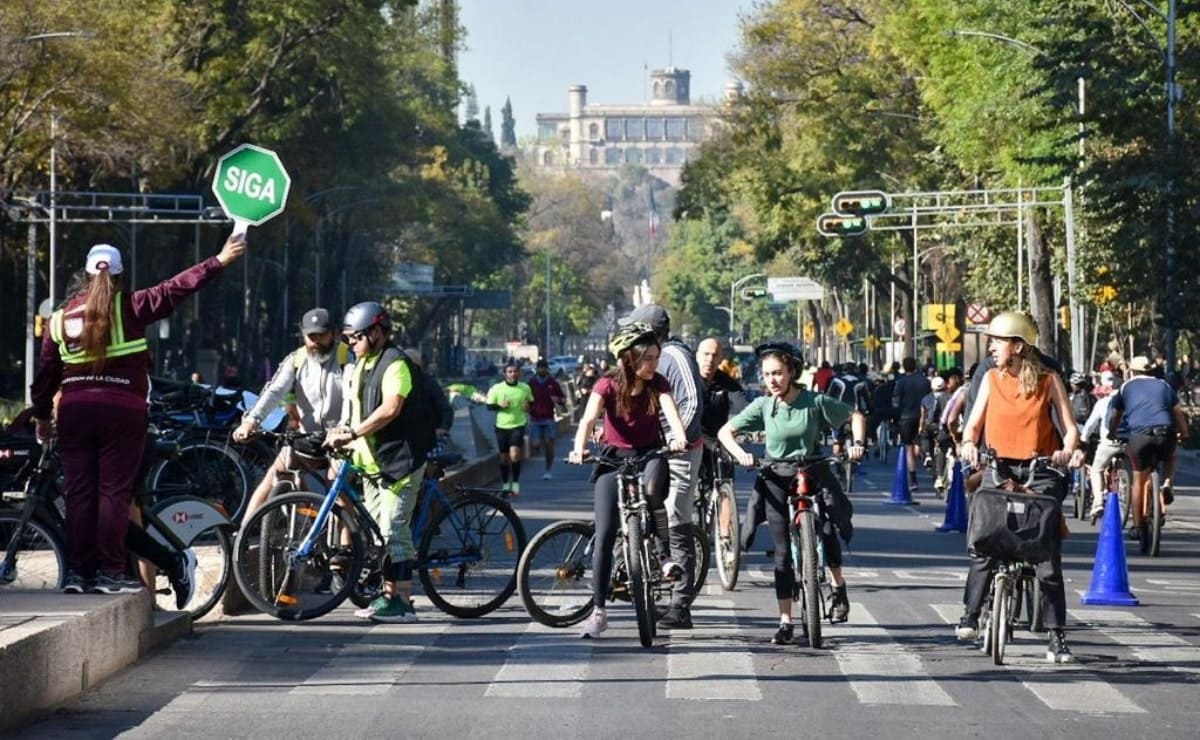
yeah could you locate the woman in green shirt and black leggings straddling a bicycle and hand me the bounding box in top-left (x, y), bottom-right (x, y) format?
top-left (718, 343), bottom-right (866, 645)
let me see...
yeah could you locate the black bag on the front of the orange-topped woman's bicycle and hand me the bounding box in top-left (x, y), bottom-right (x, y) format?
top-left (967, 488), bottom-right (1062, 564)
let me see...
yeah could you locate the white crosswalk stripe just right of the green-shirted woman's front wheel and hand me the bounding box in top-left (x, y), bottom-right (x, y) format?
top-left (834, 603), bottom-right (958, 706)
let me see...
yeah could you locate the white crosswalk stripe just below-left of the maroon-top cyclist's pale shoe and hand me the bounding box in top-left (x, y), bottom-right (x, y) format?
top-left (485, 622), bottom-right (593, 698)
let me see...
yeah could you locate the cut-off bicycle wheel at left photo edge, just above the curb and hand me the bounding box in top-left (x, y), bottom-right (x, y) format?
top-left (0, 511), bottom-right (67, 590)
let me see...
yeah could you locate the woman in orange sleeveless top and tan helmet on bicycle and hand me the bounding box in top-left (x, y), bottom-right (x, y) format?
top-left (955, 311), bottom-right (1082, 663)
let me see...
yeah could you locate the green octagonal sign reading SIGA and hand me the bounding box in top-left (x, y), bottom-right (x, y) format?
top-left (212, 144), bottom-right (292, 227)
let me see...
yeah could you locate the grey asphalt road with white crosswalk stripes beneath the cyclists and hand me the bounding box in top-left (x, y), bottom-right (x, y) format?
top-left (11, 440), bottom-right (1200, 739)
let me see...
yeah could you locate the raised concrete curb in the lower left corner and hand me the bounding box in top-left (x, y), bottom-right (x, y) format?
top-left (0, 590), bottom-right (192, 730)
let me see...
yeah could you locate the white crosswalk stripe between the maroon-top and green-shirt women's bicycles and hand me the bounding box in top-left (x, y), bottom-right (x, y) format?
top-left (666, 598), bottom-right (762, 702)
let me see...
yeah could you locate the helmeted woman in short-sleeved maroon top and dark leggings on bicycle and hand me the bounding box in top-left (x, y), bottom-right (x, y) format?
top-left (568, 321), bottom-right (686, 637)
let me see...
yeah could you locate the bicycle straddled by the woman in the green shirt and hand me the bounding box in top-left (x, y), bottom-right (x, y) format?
top-left (755, 456), bottom-right (838, 650)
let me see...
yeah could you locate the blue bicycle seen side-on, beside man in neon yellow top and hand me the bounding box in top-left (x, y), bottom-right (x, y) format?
top-left (234, 441), bottom-right (526, 621)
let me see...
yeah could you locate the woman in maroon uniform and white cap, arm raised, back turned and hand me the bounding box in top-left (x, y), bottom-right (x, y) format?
top-left (31, 234), bottom-right (246, 594)
